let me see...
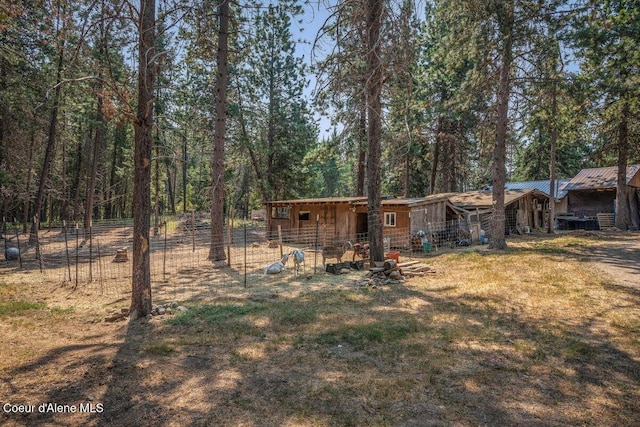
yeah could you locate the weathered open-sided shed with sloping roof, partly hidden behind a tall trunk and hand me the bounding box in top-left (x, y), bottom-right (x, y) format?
top-left (450, 188), bottom-right (549, 234)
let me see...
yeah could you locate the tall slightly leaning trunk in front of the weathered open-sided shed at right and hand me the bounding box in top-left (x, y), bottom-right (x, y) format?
top-left (490, 2), bottom-right (513, 249)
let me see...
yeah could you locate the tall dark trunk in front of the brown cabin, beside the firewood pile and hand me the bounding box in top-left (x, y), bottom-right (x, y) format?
top-left (366, 0), bottom-right (384, 261)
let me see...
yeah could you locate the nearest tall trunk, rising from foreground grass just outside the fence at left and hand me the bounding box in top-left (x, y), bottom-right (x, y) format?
top-left (130, 0), bottom-right (156, 321)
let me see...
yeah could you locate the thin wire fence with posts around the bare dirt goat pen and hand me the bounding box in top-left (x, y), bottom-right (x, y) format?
top-left (2, 214), bottom-right (480, 299)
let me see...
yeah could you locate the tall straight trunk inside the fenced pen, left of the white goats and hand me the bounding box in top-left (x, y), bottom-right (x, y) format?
top-left (209, 0), bottom-right (229, 262)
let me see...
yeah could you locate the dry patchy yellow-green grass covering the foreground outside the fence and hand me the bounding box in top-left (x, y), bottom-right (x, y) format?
top-left (0, 234), bottom-right (640, 426)
